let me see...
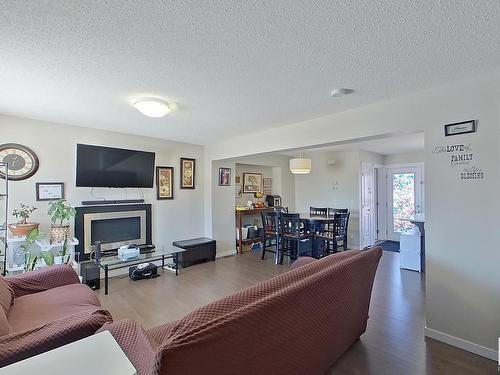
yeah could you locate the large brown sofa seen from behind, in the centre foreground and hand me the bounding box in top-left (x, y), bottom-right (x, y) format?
top-left (101, 248), bottom-right (382, 375)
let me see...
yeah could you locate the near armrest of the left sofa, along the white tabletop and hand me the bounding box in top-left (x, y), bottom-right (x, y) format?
top-left (0, 309), bottom-right (112, 372)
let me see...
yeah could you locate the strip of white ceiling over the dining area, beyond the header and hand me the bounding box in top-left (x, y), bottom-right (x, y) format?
top-left (281, 133), bottom-right (424, 157)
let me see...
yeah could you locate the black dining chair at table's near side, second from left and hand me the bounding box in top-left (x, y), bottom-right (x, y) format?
top-left (280, 214), bottom-right (312, 264)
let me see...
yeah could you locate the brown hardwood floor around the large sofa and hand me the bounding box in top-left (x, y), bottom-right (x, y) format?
top-left (96, 252), bottom-right (497, 375)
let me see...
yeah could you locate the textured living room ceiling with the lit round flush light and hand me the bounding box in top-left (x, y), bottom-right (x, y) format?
top-left (0, 0), bottom-right (500, 144)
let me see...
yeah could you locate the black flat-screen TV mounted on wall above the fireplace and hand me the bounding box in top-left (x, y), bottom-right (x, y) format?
top-left (76, 144), bottom-right (155, 188)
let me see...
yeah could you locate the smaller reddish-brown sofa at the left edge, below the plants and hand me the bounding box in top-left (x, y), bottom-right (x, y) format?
top-left (0, 265), bottom-right (112, 371)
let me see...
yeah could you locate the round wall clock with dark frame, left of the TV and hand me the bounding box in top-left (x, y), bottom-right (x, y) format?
top-left (0, 143), bottom-right (38, 181)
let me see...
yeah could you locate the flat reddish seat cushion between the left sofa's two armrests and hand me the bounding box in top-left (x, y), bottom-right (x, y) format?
top-left (7, 284), bottom-right (100, 332)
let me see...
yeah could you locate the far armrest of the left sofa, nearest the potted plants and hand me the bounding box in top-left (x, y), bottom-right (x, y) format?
top-left (5, 264), bottom-right (80, 298)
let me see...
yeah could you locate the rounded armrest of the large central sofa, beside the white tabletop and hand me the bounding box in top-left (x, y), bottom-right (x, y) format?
top-left (98, 319), bottom-right (160, 374)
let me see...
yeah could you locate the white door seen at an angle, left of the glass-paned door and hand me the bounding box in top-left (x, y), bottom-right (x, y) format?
top-left (360, 162), bottom-right (375, 248)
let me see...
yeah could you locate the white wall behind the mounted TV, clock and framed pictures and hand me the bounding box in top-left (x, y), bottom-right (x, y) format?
top-left (0, 116), bottom-right (204, 247)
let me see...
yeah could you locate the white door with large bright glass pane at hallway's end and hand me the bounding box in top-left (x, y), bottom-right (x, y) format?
top-left (387, 167), bottom-right (423, 241)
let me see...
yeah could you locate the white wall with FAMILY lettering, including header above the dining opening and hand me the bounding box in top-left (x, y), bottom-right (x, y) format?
top-left (205, 72), bottom-right (500, 358)
